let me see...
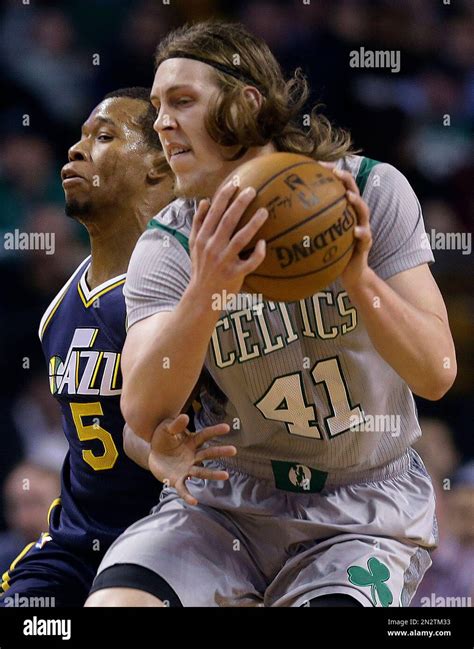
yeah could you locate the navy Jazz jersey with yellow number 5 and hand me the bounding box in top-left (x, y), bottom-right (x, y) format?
top-left (39, 258), bottom-right (161, 557)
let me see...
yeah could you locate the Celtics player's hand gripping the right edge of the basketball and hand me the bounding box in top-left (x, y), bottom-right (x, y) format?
top-left (333, 169), bottom-right (372, 290)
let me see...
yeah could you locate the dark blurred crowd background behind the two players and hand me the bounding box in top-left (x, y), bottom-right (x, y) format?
top-left (0, 0), bottom-right (474, 604)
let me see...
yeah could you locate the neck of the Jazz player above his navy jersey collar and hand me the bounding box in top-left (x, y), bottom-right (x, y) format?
top-left (87, 210), bottom-right (147, 289)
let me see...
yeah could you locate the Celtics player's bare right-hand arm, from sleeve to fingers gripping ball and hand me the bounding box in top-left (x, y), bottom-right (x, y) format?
top-left (334, 170), bottom-right (456, 399)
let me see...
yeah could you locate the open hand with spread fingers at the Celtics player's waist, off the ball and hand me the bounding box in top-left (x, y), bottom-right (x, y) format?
top-left (148, 414), bottom-right (237, 505)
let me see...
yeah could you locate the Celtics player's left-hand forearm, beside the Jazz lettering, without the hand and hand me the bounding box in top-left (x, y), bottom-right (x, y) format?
top-left (121, 282), bottom-right (220, 441)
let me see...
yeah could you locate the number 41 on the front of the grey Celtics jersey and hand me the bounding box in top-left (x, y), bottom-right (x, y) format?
top-left (255, 357), bottom-right (364, 439)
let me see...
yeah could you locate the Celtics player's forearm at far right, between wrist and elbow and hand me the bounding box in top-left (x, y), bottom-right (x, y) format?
top-left (347, 269), bottom-right (456, 400)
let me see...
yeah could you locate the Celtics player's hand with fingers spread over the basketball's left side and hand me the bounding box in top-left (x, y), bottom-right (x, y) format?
top-left (189, 182), bottom-right (268, 295)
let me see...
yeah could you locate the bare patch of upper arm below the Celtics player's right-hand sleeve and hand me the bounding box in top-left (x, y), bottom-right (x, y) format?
top-left (386, 264), bottom-right (448, 324)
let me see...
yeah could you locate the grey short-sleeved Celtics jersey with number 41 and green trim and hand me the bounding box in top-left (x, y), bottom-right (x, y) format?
top-left (124, 156), bottom-right (433, 491)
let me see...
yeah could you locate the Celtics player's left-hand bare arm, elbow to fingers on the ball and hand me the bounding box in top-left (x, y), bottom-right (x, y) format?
top-left (121, 183), bottom-right (268, 441)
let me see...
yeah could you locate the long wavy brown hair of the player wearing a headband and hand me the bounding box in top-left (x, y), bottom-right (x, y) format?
top-left (155, 20), bottom-right (355, 162)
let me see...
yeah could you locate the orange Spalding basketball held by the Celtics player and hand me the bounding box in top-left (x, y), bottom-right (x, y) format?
top-left (232, 153), bottom-right (356, 302)
